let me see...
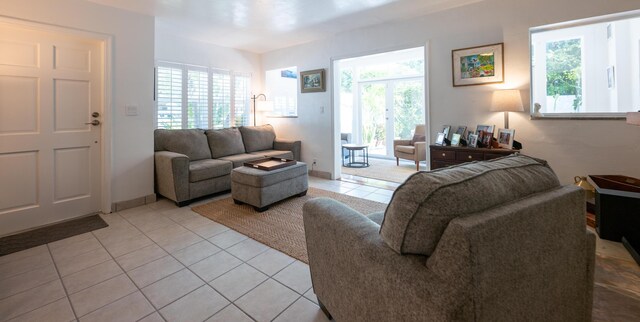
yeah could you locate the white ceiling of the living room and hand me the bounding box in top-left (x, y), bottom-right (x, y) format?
top-left (87, 0), bottom-right (482, 53)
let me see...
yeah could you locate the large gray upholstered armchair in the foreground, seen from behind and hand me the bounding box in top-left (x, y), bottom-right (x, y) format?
top-left (303, 156), bottom-right (595, 321)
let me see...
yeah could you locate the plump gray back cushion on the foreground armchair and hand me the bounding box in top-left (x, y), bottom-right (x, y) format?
top-left (380, 155), bottom-right (560, 256)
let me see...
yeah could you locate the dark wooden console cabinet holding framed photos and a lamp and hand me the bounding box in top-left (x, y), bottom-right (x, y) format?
top-left (429, 145), bottom-right (522, 170)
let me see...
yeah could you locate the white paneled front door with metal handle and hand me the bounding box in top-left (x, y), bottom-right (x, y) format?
top-left (0, 23), bottom-right (104, 236)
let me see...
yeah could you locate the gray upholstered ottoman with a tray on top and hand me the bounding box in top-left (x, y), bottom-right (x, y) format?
top-left (231, 162), bottom-right (309, 212)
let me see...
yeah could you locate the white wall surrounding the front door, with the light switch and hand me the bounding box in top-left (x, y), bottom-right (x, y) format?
top-left (0, 0), bottom-right (154, 202)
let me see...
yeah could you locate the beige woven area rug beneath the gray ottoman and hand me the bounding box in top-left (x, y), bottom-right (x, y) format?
top-left (192, 188), bottom-right (387, 263)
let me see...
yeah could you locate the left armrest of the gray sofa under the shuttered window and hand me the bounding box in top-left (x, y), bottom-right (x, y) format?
top-left (154, 151), bottom-right (190, 203)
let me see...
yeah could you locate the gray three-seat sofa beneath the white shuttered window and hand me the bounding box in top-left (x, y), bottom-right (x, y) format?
top-left (154, 125), bottom-right (301, 206)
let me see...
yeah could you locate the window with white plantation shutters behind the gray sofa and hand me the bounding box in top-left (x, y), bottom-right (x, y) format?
top-left (156, 62), bottom-right (251, 129)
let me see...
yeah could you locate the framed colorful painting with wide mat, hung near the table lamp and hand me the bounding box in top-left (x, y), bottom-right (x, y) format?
top-left (451, 43), bottom-right (504, 87)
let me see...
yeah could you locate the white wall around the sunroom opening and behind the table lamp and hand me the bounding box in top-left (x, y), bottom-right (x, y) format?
top-left (262, 0), bottom-right (640, 183)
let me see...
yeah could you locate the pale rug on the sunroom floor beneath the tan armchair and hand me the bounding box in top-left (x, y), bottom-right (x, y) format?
top-left (342, 158), bottom-right (426, 183)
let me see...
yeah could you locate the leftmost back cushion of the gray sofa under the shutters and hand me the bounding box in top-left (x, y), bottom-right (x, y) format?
top-left (153, 129), bottom-right (211, 161)
